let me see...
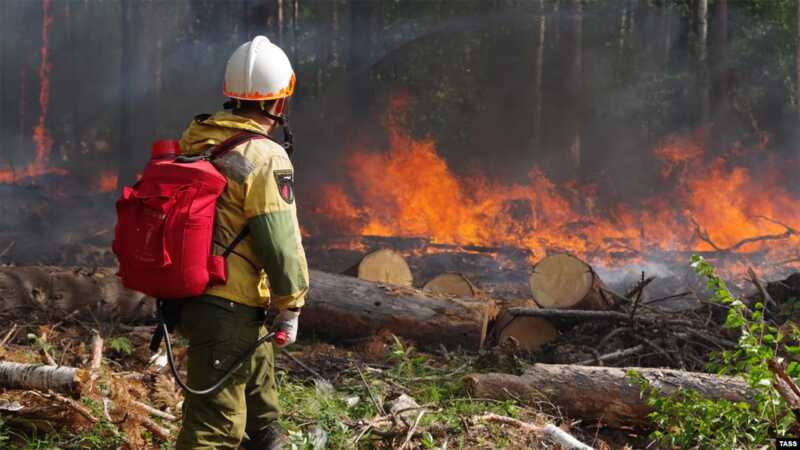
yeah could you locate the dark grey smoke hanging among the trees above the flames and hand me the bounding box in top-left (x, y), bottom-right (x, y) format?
top-left (0, 0), bottom-right (800, 273)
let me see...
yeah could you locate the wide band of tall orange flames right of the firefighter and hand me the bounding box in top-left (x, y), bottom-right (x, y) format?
top-left (313, 99), bottom-right (800, 274)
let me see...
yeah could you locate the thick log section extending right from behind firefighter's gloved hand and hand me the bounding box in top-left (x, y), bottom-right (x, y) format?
top-left (300, 270), bottom-right (494, 350)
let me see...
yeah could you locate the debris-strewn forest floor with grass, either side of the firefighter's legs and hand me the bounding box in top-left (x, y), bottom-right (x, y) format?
top-left (0, 310), bottom-right (647, 449)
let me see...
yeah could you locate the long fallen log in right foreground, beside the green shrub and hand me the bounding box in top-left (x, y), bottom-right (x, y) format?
top-left (464, 364), bottom-right (751, 426)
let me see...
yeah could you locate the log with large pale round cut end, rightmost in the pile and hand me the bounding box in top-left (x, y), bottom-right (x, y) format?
top-left (530, 254), bottom-right (614, 310)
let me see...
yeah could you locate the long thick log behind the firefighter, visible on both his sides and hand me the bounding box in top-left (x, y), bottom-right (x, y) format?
top-left (0, 267), bottom-right (494, 350)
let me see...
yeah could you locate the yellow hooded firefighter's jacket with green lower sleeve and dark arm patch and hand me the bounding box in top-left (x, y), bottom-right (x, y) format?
top-left (180, 112), bottom-right (308, 310)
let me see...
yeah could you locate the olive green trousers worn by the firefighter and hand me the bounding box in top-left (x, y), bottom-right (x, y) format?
top-left (175, 295), bottom-right (280, 450)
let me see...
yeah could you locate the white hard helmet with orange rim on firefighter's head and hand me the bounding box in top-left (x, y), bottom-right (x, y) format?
top-left (222, 36), bottom-right (295, 101)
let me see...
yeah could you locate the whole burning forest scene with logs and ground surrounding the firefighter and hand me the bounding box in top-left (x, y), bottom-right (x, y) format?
top-left (0, 0), bottom-right (800, 449)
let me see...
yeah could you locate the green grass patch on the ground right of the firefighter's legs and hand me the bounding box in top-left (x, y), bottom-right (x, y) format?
top-left (277, 341), bottom-right (520, 449)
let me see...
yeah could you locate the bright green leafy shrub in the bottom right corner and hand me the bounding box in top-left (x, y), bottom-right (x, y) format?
top-left (630, 256), bottom-right (800, 449)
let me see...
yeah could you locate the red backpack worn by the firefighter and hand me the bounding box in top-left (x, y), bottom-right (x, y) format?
top-left (112, 132), bottom-right (264, 299)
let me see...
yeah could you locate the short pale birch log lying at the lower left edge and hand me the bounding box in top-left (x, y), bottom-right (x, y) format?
top-left (0, 361), bottom-right (88, 398)
